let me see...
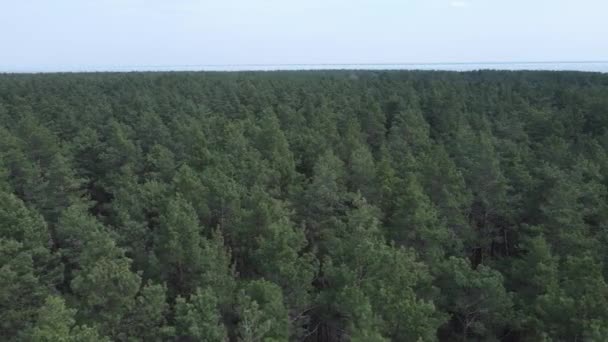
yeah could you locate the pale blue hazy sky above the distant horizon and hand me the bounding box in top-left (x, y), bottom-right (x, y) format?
top-left (0, 0), bottom-right (608, 71)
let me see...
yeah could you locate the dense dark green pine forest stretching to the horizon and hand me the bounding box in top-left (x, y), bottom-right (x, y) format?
top-left (0, 70), bottom-right (608, 342)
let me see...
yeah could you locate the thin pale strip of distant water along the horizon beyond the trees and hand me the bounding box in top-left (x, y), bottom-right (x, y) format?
top-left (0, 61), bottom-right (608, 73)
